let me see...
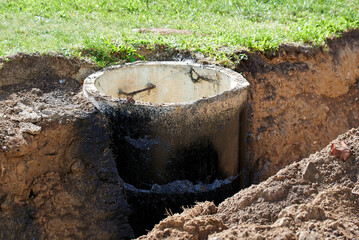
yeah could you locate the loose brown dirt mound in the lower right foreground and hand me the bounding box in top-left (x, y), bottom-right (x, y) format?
top-left (140, 128), bottom-right (359, 240)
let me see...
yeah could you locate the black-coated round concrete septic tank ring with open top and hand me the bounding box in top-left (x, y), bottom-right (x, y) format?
top-left (84, 62), bottom-right (249, 235)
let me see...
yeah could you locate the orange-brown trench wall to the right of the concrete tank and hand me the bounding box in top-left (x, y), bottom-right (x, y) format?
top-left (236, 31), bottom-right (359, 183)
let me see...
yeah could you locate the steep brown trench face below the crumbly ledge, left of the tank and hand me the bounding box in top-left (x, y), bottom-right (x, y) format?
top-left (0, 113), bottom-right (132, 239)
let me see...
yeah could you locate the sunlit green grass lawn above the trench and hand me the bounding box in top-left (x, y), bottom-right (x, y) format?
top-left (0, 0), bottom-right (359, 65)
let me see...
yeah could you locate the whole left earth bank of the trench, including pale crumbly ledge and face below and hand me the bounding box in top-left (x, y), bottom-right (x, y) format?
top-left (0, 54), bottom-right (133, 239)
